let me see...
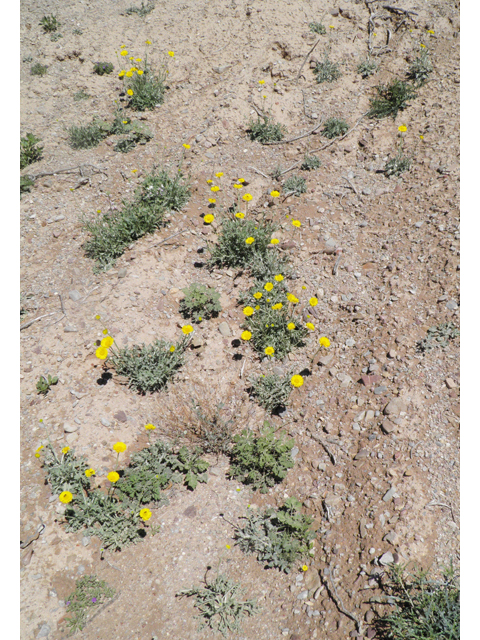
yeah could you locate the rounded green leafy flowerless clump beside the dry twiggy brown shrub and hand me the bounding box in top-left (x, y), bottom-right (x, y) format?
top-left (229, 422), bottom-right (295, 493)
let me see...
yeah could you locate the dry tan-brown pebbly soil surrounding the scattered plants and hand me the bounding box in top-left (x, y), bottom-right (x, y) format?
top-left (20, 0), bottom-right (460, 640)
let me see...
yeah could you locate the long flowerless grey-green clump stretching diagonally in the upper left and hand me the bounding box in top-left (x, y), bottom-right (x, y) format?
top-left (83, 168), bottom-right (190, 270)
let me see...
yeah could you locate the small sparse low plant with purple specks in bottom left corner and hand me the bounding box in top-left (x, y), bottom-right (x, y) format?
top-left (65, 576), bottom-right (115, 633)
